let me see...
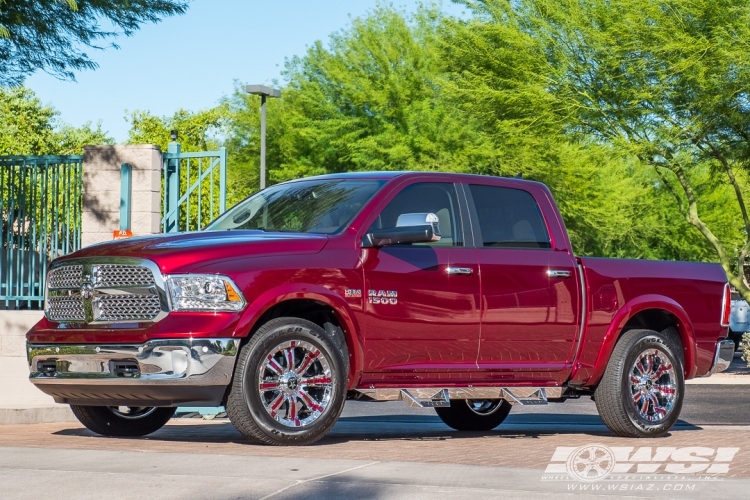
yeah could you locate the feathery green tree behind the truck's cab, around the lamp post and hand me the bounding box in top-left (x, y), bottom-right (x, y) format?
top-left (227, 8), bottom-right (502, 195)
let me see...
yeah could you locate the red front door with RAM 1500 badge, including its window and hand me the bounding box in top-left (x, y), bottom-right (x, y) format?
top-left (363, 182), bottom-right (479, 384)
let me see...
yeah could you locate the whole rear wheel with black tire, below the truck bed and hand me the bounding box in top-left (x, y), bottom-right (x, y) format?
top-left (594, 328), bottom-right (685, 438)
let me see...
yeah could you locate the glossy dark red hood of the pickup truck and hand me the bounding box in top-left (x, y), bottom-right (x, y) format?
top-left (62, 230), bottom-right (328, 273)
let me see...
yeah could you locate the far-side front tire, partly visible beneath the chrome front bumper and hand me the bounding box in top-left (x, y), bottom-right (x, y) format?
top-left (70, 405), bottom-right (177, 437)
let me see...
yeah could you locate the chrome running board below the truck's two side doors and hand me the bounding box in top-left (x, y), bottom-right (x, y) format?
top-left (357, 387), bottom-right (563, 408)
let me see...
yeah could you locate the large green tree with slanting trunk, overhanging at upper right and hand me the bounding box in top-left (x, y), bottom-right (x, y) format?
top-left (448, 0), bottom-right (750, 292)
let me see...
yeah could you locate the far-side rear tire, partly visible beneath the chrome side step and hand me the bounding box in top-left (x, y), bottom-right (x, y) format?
top-left (435, 399), bottom-right (513, 431)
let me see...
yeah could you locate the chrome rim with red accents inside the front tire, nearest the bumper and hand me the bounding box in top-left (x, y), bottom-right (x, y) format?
top-left (258, 340), bottom-right (333, 427)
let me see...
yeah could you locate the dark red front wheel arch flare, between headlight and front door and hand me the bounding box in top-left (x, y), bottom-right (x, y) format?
top-left (237, 284), bottom-right (364, 389)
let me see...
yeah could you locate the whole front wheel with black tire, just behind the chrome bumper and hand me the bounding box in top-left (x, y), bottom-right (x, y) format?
top-left (226, 317), bottom-right (349, 446)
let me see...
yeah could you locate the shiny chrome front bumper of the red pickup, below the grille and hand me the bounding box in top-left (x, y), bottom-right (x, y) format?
top-left (26, 339), bottom-right (239, 406)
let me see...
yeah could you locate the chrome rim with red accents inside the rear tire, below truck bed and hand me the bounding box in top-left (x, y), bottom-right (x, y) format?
top-left (630, 349), bottom-right (678, 423)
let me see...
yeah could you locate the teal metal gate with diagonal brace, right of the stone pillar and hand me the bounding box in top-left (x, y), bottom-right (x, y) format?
top-left (161, 142), bottom-right (227, 233)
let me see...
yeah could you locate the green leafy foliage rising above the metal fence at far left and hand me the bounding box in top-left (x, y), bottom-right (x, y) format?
top-left (0, 87), bottom-right (114, 156)
